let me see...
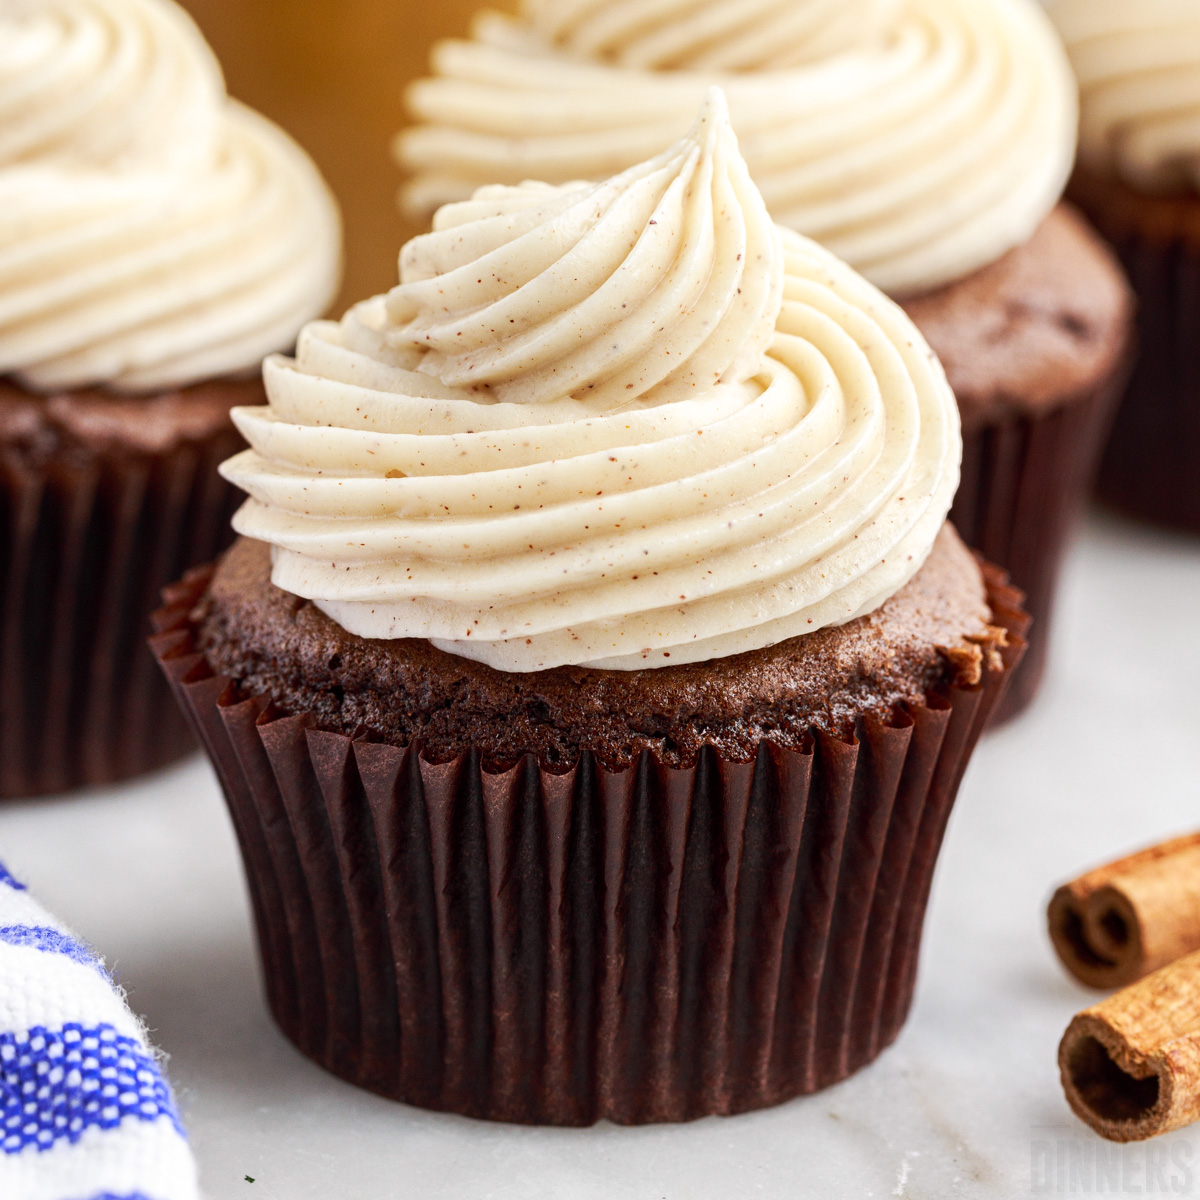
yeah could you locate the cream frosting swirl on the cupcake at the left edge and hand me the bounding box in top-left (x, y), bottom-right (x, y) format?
top-left (0, 0), bottom-right (341, 391)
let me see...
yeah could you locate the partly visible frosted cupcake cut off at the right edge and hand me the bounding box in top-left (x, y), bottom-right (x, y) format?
top-left (1049, 0), bottom-right (1200, 533)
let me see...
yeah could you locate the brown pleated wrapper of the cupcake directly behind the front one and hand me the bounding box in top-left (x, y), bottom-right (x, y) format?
top-left (950, 356), bottom-right (1129, 725)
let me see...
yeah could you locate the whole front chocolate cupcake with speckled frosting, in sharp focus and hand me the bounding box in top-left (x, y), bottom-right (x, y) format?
top-left (154, 90), bottom-right (1026, 1124)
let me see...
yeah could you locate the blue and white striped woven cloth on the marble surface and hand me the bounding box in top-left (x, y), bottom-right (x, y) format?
top-left (0, 864), bottom-right (199, 1200)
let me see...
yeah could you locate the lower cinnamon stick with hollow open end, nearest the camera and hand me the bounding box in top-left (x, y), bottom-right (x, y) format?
top-left (1058, 952), bottom-right (1200, 1141)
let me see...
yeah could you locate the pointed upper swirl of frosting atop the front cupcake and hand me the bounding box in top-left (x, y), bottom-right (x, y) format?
top-left (386, 88), bottom-right (784, 404)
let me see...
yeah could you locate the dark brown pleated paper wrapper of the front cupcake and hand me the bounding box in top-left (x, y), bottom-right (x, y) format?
top-left (151, 568), bottom-right (1027, 1124)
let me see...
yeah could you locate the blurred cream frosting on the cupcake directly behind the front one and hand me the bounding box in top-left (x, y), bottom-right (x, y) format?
top-left (397, 0), bottom-right (1076, 295)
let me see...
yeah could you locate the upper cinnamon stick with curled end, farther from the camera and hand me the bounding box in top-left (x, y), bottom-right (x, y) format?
top-left (1048, 833), bottom-right (1200, 989)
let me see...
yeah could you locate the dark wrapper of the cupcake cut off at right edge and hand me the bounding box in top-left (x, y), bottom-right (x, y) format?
top-left (1098, 225), bottom-right (1200, 533)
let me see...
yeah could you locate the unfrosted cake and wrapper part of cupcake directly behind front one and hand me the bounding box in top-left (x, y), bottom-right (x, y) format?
top-left (905, 204), bottom-right (1130, 720)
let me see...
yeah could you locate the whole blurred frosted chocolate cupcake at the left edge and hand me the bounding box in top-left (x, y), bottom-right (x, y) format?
top-left (0, 0), bottom-right (340, 797)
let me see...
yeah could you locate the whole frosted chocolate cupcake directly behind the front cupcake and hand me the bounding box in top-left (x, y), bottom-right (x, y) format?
top-left (397, 0), bottom-right (1130, 716)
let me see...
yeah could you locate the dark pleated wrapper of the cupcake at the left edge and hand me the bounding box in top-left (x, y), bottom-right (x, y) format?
top-left (0, 426), bottom-right (240, 799)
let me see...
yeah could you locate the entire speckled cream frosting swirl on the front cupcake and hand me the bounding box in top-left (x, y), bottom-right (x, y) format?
top-left (223, 90), bottom-right (961, 671)
